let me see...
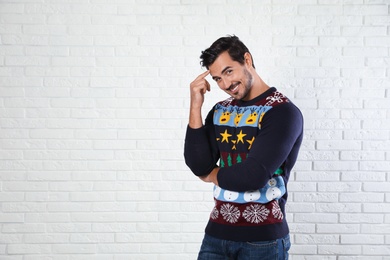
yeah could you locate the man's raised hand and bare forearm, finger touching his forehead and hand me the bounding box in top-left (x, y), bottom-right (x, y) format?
top-left (189, 70), bottom-right (210, 128)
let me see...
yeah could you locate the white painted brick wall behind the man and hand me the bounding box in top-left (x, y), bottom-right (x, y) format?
top-left (0, 0), bottom-right (390, 260)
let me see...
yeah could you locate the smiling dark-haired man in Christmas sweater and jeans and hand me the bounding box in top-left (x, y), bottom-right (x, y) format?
top-left (184, 36), bottom-right (303, 260)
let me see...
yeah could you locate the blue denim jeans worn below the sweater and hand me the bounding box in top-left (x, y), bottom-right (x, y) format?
top-left (198, 234), bottom-right (291, 260)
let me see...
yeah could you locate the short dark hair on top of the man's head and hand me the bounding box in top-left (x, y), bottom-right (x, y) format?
top-left (200, 35), bottom-right (255, 69)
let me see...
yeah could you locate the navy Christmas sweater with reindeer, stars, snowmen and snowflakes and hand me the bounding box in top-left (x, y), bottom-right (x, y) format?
top-left (184, 88), bottom-right (303, 241)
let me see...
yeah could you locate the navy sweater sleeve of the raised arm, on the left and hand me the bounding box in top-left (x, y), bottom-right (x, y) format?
top-left (184, 108), bottom-right (219, 176)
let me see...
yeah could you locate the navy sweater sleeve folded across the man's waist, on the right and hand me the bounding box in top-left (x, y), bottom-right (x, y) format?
top-left (217, 103), bottom-right (303, 192)
